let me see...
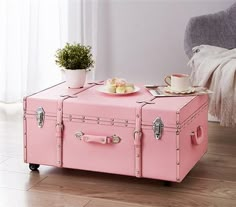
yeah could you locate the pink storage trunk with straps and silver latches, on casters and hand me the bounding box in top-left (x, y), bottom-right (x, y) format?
top-left (24, 83), bottom-right (208, 182)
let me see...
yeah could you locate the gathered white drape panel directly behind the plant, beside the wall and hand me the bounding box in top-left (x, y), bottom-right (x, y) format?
top-left (68, 0), bottom-right (98, 81)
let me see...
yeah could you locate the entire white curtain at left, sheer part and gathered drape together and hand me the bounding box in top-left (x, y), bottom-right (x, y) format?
top-left (0, 0), bottom-right (98, 103)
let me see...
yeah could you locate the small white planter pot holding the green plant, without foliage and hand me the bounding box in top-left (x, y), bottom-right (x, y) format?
top-left (65, 69), bottom-right (86, 88)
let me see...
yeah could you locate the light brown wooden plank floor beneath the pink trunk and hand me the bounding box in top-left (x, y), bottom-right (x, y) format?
top-left (0, 104), bottom-right (236, 207)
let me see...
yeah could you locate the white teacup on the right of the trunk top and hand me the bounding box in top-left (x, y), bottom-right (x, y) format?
top-left (164, 73), bottom-right (191, 92)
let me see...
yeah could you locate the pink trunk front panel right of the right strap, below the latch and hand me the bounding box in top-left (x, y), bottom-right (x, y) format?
top-left (142, 127), bottom-right (177, 181)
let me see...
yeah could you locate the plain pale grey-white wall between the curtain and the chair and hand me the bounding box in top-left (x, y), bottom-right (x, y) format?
top-left (96, 0), bottom-right (235, 84)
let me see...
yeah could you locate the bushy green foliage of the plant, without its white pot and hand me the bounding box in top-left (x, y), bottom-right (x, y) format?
top-left (55, 43), bottom-right (94, 70)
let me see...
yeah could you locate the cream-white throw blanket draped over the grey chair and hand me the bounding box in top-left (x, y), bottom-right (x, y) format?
top-left (189, 45), bottom-right (236, 127)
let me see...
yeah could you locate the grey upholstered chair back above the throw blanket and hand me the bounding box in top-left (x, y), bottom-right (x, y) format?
top-left (184, 3), bottom-right (236, 58)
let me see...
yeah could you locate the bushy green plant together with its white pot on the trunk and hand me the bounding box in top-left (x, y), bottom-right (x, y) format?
top-left (55, 43), bottom-right (94, 88)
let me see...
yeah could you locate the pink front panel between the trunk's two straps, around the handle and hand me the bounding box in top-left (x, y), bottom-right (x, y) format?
top-left (63, 121), bottom-right (135, 175)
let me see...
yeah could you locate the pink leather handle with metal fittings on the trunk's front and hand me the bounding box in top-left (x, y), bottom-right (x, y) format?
top-left (75, 131), bottom-right (121, 144)
